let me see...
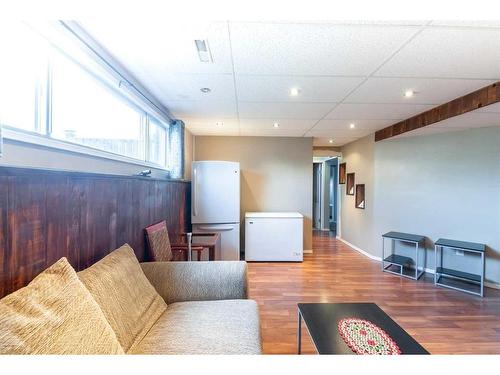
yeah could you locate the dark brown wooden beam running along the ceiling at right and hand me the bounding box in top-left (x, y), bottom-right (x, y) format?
top-left (375, 81), bottom-right (500, 142)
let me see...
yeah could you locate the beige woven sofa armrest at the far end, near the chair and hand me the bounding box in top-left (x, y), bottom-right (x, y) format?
top-left (141, 261), bottom-right (248, 303)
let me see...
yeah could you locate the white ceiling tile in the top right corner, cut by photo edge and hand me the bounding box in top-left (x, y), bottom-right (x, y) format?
top-left (375, 27), bottom-right (500, 79)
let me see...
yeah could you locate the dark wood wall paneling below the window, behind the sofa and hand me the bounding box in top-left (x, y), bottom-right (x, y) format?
top-left (0, 167), bottom-right (190, 297)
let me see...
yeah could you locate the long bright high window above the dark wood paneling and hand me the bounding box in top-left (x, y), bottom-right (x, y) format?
top-left (0, 23), bottom-right (170, 169)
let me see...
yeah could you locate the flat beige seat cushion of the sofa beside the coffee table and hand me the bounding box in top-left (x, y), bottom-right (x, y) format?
top-left (131, 300), bottom-right (262, 354)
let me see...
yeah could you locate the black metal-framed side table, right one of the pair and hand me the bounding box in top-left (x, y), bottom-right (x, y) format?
top-left (434, 238), bottom-right (486, 297)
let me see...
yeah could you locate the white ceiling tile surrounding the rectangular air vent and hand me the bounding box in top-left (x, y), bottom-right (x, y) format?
top-left (81, 17), bottom-right (232, 78)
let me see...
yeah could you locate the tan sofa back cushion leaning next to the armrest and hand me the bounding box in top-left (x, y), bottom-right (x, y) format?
top-left (78, 245), bottom-right (167, 352)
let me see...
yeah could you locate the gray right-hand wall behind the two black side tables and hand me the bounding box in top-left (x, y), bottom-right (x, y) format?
top-left (342, 127), bottom-right (500, 284)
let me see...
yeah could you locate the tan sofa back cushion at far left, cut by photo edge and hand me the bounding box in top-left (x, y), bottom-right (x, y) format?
top-left (0, 258), bottom-right (123, 354)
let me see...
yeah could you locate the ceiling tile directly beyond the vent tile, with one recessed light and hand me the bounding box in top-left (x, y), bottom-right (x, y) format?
top-left (137, 71), bottom-right (235, 102)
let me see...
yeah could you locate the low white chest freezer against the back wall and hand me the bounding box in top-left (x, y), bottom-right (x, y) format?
top-left (245, 212), bottom-right (304, 262)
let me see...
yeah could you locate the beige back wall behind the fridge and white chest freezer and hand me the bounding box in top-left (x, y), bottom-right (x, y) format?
top-left (195, 136), bottom-right (313, 250)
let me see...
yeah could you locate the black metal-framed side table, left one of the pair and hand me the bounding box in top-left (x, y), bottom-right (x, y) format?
top-left (382, 232), bottom-right (425, 280)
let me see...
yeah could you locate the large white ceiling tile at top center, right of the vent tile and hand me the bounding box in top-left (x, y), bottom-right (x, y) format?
top-left (230, 22), bottom-right (420, 76)
